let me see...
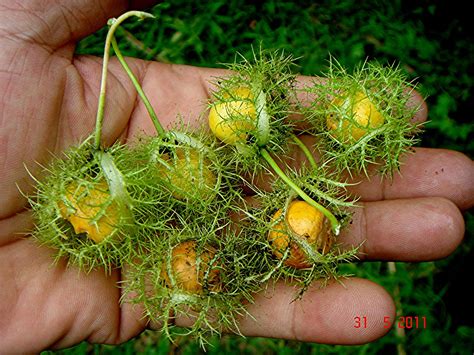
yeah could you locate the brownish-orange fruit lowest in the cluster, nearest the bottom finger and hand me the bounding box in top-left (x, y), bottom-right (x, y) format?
top-left (161, 240), bottom-right (221, 294)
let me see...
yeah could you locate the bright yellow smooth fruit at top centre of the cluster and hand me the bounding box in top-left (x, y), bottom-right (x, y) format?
top-left (209, 87), bottom-right (257, 144)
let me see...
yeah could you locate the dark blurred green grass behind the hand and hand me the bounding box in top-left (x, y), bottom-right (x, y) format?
top-left (44, 0), bottom-right (474, 354)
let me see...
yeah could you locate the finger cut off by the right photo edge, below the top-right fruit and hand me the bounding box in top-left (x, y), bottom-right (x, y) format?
top-left (350, 148), bottom-right (474, 210)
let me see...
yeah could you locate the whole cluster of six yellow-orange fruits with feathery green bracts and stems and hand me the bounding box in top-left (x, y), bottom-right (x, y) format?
top-left (30, 14), bottom-right (419, 344)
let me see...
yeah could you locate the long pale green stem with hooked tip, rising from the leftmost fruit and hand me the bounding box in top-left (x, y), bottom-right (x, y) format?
top-left (94, 11), bottom-right (154, 150)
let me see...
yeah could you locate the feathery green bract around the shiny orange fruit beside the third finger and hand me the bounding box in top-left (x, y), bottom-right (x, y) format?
top-left (240, 166), bottom-right (358, 297)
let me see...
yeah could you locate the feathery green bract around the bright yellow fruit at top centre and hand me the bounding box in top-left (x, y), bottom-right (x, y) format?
top-left (210, 48), bottom-right (296, 174)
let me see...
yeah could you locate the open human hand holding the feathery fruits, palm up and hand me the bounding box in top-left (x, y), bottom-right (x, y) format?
top-left (0, 0), bottom-right (474, 353)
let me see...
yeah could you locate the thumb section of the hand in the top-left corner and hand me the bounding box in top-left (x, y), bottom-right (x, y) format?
top-left (0, 0), bottom-right (157, 52)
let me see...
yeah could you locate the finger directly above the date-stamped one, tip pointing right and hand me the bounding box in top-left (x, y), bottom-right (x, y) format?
top-left (339, 197), bottom-right (464, 261)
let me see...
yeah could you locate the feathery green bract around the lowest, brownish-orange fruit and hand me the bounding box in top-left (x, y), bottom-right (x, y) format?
top-left (122, 222), bottom-right (261, 343)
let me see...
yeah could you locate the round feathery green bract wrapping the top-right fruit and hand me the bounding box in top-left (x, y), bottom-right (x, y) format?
top-left (303, 59), bottom-right (420, 176)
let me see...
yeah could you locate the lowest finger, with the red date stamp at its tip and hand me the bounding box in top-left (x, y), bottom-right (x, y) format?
top-left (176, 278), bottom-right (395, 345)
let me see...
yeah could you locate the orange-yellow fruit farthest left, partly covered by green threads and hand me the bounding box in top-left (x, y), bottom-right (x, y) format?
top-left (58, 181), bottom-right (120, 243)
